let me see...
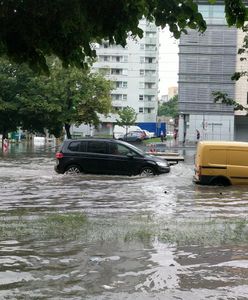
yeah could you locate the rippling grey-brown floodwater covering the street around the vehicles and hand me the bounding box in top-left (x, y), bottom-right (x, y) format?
top-left (0, 144), bottom-right (248, 300)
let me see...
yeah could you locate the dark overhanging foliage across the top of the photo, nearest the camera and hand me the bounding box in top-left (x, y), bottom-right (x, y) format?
top-left (0, 0), bottom-right (247, 73)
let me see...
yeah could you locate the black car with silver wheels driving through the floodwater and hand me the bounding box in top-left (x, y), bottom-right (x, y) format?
top-left (55, 138), bottom-right (170, 176)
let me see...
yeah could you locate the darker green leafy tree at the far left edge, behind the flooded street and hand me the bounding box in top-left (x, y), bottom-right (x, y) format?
top-left (0, 58), bottom-right (60, 139)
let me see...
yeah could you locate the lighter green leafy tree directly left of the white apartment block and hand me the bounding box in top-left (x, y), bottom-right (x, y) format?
top-left (46, 62), bottom-right (113, 138)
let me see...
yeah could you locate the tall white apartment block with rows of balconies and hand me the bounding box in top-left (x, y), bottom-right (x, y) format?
top-left (93, 19), bottom-right (159, 133)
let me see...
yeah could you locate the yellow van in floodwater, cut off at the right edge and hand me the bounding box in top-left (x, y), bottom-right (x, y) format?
top-left (194, 141), bottom-right (248, 185)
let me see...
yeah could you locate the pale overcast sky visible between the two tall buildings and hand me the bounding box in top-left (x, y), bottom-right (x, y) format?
top-left (159, 29), bottom-right (178, 96)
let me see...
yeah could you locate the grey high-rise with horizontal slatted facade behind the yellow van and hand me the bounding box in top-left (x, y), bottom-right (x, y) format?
top-left (178, 1), bottom-right (248, 142)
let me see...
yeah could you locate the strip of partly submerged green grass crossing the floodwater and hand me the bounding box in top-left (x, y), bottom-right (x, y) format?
top-left (0, 211), bottom-right (248, 246)
